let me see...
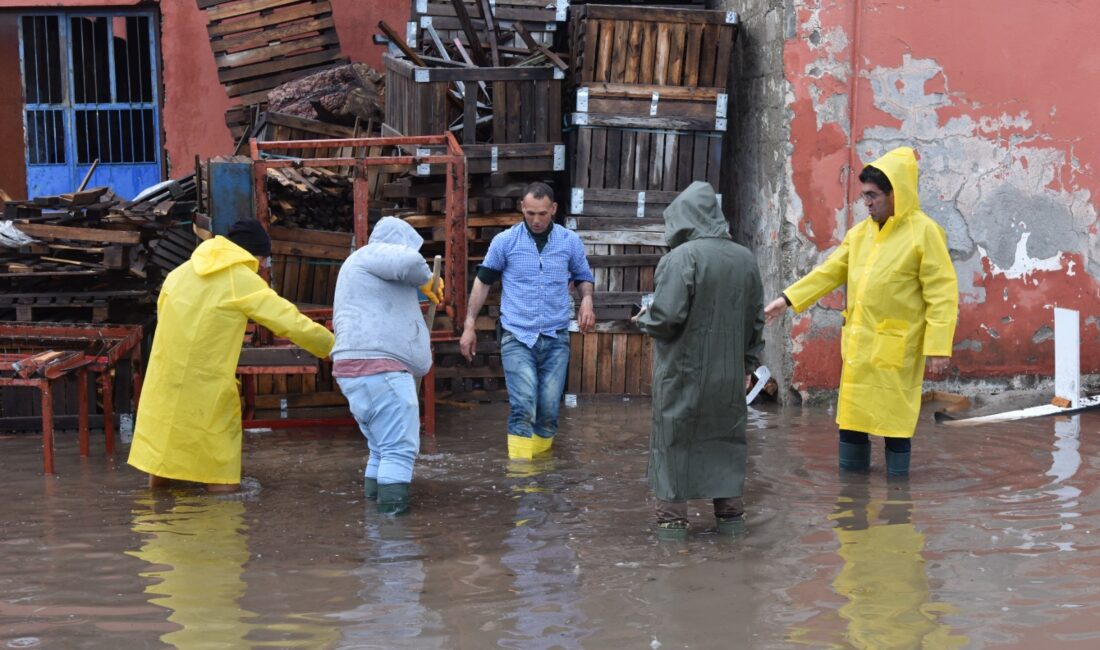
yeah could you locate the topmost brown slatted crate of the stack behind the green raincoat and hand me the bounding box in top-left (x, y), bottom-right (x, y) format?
top-left (570, 4), bottom-right (738, 88)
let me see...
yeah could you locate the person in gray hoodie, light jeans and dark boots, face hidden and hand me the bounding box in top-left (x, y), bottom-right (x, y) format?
top-left (331, 217), bottom-right (443, 515)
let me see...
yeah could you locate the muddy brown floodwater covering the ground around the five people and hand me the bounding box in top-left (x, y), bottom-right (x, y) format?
top-left (0, 399), bottom-right (1100, 650)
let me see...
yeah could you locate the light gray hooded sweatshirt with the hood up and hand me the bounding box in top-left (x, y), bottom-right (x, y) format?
top-left (332, 217), bottom-right (431, 377)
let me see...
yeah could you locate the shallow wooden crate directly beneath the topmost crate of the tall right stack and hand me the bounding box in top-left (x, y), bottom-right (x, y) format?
top-left (570, 84), bottom-right (728, 131)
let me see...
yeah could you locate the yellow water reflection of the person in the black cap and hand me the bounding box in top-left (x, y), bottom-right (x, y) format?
top-left (129, 496), bottom-right (255, 649)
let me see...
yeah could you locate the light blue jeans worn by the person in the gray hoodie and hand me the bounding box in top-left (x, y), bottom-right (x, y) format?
top-left (337, 372), bottom-right (420, 485)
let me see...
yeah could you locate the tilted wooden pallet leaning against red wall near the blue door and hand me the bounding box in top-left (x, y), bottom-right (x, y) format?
top-left (197, 0), bottom-right (348, 137)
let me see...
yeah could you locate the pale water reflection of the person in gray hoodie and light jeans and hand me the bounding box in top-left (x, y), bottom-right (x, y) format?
top-left (334, 516), bottom-right (448, 649)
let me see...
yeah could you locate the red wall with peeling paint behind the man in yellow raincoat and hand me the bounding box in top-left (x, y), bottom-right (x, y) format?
top-left (784, 0), bottom-right (1100, 390)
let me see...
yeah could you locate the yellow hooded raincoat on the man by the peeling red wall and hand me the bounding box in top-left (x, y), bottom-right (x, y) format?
top-left (783, 146), bottom-right (958, 438)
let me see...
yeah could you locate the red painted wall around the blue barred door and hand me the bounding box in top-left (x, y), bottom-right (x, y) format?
top-left (0, 0), bottom-right (409, 188)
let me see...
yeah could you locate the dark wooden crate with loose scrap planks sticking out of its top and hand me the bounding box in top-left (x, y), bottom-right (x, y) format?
top-left (383, 56), bottom-right (565, 174)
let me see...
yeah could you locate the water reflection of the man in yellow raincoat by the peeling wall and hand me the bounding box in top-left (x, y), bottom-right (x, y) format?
top-left (791, 476), bottom-right (969, 650)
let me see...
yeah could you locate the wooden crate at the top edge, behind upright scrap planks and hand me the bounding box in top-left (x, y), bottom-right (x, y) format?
top-left (409, 0), bottom-right (570, 48)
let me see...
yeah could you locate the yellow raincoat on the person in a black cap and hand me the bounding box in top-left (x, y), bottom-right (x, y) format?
top-left (129, 236), bottom-right (333, 483)
